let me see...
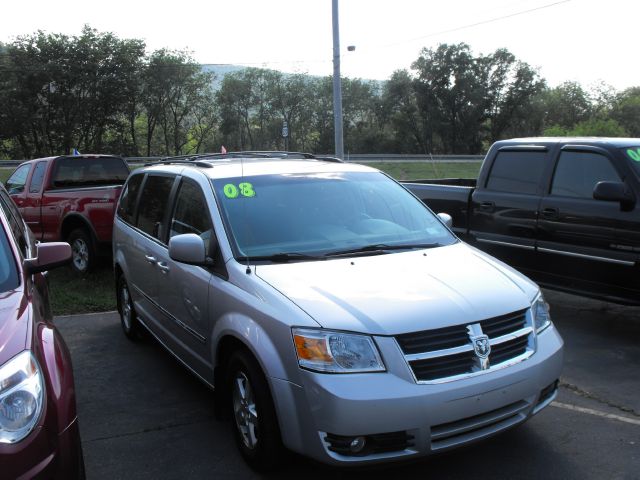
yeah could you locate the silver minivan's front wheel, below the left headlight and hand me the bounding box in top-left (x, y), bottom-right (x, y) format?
top-left (227, 350), bottom-right (284, 472)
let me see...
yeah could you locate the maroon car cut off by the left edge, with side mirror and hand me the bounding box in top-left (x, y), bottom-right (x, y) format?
top-left (0, 187), bottom-right (84, 479)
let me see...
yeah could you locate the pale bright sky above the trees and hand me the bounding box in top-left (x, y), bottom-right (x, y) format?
top-left (0, 0), bottom-right (640, 90)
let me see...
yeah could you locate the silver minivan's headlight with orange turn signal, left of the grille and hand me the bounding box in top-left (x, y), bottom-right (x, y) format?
top-left (293, 328), bottom-right (385, 373)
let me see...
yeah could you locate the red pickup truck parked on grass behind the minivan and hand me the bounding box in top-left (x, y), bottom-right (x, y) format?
top-left (5, 155), bottom-right (129, 273)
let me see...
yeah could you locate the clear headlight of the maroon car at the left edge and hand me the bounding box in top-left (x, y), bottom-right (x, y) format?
top-left (0, 351), bottom-right (44, 443)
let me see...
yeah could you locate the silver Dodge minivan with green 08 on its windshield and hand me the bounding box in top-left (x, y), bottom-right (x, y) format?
top-left (113, 152), bottom-right (563, 470)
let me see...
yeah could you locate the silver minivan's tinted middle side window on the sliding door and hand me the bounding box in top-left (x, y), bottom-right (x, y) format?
top-left (137, 175), bottom-right (174, 240)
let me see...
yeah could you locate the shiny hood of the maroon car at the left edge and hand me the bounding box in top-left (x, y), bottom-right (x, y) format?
top-left (0, 289), bottom-right (29, 365)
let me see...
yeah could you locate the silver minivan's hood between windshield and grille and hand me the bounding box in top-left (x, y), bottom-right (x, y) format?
top-left (255, 242), bottom-right (538, 335)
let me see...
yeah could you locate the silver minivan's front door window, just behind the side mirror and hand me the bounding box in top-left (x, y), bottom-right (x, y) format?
top-left (169, 182), bottom-right (213, 256)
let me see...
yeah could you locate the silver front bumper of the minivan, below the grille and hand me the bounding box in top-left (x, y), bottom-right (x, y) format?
top-left (271, 326), bottom-right (563, 465)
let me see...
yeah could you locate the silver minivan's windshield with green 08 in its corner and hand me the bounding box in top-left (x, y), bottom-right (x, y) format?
top-left (213, 172), bottom-right (457, 262)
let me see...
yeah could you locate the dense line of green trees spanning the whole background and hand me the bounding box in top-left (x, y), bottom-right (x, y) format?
top-left (0, 27), bottom-right (640, 158)
